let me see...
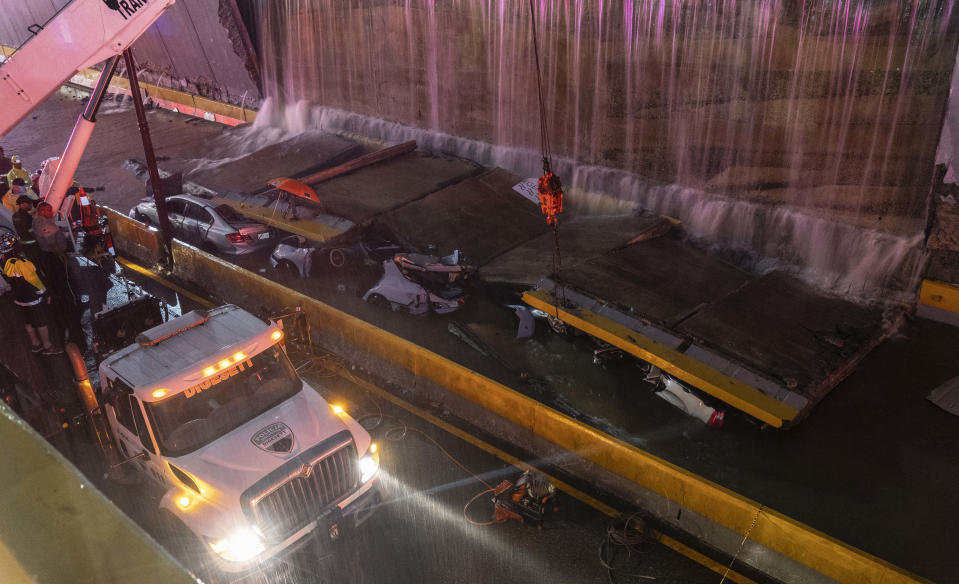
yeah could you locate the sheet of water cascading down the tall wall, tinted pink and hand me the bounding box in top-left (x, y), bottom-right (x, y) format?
top-left (254, 0), bottom-right (959, 291)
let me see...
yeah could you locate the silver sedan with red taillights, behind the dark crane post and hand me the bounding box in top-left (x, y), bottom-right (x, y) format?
top-left (130, 195), bottom-right (274, 255)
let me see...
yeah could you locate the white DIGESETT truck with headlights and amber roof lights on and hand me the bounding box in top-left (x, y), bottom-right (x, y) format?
top-left (99, 305), bottom-right (379, 572)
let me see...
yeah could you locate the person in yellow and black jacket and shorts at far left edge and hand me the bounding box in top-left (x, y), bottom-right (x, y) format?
top-left (0, 233), bottom-right (63, 355)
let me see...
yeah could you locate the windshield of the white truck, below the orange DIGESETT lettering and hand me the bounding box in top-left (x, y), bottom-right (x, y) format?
top-left (144, 345), bottom-right (303, 456)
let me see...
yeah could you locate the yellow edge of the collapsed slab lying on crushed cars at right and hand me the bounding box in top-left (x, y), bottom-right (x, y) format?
top-left (523, 290), bottom-right (799, 428)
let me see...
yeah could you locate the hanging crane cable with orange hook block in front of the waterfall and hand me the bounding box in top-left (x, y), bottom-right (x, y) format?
top-left (529, 0), bottom-right (566, 319)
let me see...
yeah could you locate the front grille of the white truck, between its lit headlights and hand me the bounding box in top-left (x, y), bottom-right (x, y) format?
top-left (250, 433), bottom-right (360, 541)
